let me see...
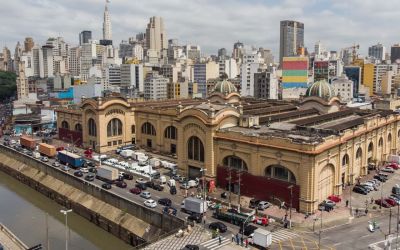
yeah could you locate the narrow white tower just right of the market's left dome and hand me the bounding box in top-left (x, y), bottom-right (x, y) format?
top-left (240, 50), bottom-right (264, 96)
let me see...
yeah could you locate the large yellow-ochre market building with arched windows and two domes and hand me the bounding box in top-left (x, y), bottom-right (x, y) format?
top-left (57, 80), bottom-right (400, 212)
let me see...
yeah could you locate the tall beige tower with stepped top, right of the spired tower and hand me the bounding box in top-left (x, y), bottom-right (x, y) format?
top-left (146, 16), bottom-right (168, 55)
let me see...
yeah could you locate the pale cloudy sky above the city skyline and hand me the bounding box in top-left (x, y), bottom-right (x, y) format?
top-left (0, 0), bottom-right (400, 56)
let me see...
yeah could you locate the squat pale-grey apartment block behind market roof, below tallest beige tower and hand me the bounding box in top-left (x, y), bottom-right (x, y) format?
top-left (144, 72), bottom-right (169, 100)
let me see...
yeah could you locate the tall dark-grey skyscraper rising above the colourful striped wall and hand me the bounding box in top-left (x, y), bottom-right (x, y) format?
top-left (279, 20), bottom-right (304, 64)
